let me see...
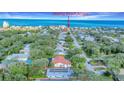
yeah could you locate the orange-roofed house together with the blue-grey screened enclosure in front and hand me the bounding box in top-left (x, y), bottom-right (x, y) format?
top-left (46, 55), bottom-right (73, 80)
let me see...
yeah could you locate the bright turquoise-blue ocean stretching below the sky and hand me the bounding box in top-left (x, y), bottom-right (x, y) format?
top-left (0, 19), bottom-right (124, 28)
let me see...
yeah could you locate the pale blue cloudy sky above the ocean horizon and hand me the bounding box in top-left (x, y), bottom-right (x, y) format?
top-left (0, 12), bottom-right (124, 20)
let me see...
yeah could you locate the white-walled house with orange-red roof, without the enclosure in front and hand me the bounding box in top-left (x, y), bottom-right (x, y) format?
top-left (52, 55), bottom-right (71, 68)
